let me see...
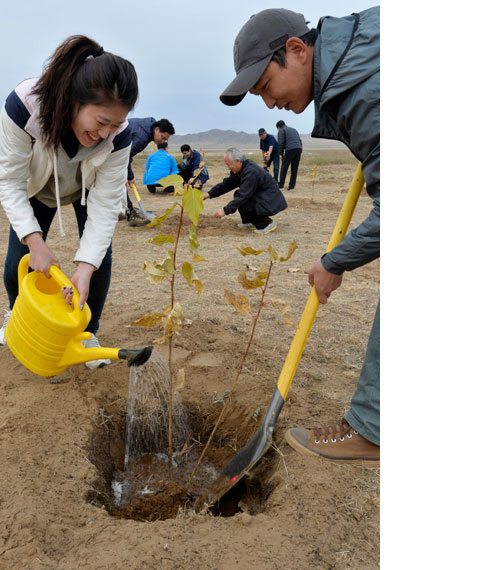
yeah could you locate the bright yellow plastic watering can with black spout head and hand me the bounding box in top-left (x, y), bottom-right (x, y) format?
top-left (5, 254), bottom-right (153, 376)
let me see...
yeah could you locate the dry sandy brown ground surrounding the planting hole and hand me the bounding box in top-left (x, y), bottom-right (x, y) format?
top-left (0, 150), bottom-right (380, 570)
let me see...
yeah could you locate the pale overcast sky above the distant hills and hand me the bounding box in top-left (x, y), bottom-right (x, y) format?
top-left (0, 0), bottom-right (379, 134)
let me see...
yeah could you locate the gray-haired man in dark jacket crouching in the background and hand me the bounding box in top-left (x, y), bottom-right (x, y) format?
top-left (203, 147), bottom-right (287, 234)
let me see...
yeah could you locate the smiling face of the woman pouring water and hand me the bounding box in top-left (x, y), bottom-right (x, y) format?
top-left (71, 105), bottom-right (129, 147)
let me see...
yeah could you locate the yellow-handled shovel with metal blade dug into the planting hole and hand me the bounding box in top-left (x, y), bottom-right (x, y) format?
top-left (208, 164), bottom-right (364, 504)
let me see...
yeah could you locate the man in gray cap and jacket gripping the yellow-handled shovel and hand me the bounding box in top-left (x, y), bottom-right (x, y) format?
top-left (220, 7), bottom-right (380, 459)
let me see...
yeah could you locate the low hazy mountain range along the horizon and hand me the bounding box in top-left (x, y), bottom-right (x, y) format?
top-left (169, 129), bottom-right (347, 152)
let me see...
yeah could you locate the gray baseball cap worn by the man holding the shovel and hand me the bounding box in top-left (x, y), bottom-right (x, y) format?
top-left (219, 8), bottom-right (309, 105)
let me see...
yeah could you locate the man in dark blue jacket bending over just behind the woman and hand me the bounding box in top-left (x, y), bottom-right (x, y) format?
top-left (127, 117), bottom-right (175, 227)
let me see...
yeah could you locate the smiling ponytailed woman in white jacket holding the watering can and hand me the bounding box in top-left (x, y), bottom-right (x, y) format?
top-left (0, 36), bottom-right (138, 368)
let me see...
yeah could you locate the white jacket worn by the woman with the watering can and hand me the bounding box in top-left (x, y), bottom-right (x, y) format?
top-left (0, 79), bottom-right (130, 267)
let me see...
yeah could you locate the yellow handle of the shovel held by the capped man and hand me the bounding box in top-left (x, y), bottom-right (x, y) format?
top-left (277, 164), bottom-right (365, 400)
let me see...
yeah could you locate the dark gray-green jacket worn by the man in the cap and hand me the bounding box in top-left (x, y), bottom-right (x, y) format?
top-left (311, 7), bottom-right (380, 275)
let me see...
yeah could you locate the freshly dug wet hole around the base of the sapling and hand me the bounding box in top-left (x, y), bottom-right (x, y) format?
top-left (87, 403), bottom-right (280, 521)
